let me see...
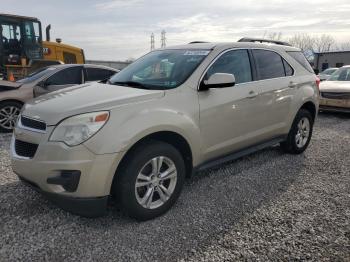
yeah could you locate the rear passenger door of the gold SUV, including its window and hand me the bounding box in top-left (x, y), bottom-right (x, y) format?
top-left (252, 49), bottom-right (298, 136)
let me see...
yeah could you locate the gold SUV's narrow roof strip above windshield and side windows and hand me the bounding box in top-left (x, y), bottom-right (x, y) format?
top-left (165, 42), bottom-right (301, 51)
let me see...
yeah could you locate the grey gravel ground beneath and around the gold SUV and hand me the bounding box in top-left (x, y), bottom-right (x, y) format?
top-left (0, 114), bottom-right (350, 261)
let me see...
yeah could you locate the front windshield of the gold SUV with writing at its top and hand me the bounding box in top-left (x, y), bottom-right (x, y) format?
top-left (109, 49), bottom-right (210, 90)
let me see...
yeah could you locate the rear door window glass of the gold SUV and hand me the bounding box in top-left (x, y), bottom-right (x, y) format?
top-left (253, 50), bottom-right (285, 80)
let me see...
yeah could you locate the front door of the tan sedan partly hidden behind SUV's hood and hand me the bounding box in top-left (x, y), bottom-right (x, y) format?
top-left (34, 66), bottom-right (83, 97)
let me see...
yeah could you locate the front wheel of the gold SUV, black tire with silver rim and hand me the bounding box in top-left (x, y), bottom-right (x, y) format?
top-left (114, 141), bottom-right (186, 221)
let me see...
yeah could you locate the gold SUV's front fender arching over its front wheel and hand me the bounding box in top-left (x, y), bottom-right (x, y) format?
top-left (85, 101), bottom-right (201, 164)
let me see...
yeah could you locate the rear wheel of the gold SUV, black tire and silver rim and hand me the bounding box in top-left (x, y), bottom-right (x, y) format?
top-left (281, 109), bottom-right (314, 154)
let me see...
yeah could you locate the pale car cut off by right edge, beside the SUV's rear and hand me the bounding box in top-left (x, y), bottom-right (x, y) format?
top-left (320, 65), bottom-right (350, 113)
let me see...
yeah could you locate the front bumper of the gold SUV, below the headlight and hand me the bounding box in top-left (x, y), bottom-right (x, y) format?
top-left (11, 128), bottom-right (121, 216)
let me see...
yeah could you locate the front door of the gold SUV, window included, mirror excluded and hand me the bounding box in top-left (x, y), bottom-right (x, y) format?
top-left (198, 49), bottom-right (265, 160)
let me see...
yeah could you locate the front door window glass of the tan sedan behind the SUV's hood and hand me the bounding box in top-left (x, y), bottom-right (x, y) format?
top-left (46, 66), bottom-right (82, 85)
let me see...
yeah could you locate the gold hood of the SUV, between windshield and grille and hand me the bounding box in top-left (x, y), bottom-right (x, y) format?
top-left (23, 82), bottom-right (164, 125)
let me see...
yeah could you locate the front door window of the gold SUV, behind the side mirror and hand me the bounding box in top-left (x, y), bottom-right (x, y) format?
top-left (206, 50), bottom-right (252, 84)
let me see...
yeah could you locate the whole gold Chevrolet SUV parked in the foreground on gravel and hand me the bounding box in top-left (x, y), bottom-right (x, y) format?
top-left (12, 39), bottom-right (319, 220)
